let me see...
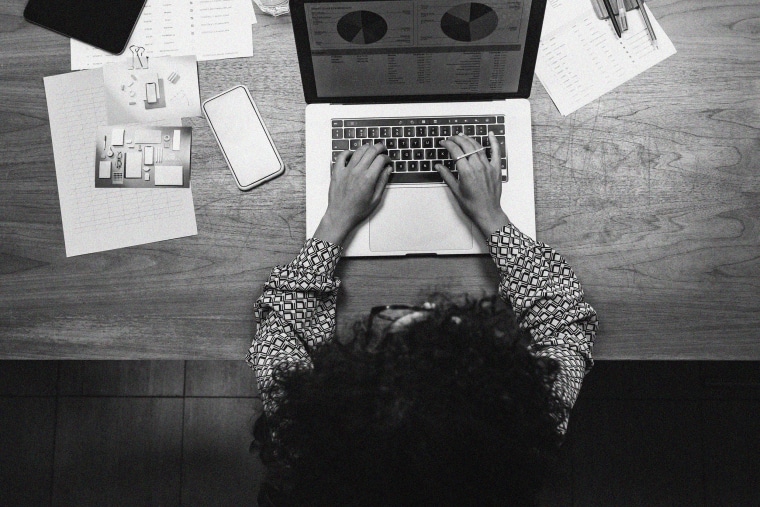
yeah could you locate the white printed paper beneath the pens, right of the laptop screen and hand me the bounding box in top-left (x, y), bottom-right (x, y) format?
top-left (536, 0), bottom-right (676, 116)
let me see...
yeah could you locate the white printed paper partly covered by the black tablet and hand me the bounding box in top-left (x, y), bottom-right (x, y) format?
top-left (71, 0), bottom-right (256, 70)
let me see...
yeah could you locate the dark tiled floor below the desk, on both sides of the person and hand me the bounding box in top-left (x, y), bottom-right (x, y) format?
top-left (0, 361), bottom-right (760, 506)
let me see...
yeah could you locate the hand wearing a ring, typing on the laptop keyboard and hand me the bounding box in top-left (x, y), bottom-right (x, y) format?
top-left (435, 132), bottom-right (509, 238)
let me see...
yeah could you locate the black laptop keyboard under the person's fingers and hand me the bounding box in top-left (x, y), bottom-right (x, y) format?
top-left (332, 115), bottom-right (509, 183)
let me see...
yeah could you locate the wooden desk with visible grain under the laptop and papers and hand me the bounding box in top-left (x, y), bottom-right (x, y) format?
top-left (0, 0), bottom-right (760, 359)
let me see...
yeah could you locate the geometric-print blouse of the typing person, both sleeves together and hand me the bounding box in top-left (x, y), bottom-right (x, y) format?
top-left (246, 224), bottom-right (598, 434)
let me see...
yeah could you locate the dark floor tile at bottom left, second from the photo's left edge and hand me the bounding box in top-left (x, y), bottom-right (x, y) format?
top-left (53, 397), bottom-right (183, 505)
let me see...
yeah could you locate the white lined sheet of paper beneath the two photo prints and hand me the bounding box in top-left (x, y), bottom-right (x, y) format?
top-left (45, 69), bottom-right (198, 257)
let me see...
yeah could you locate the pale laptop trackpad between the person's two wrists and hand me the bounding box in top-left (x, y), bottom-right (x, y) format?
top-left (369, 185), bottom-right (473, 253)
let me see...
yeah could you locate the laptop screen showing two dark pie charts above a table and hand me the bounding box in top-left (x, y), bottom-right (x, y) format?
top-left (297, 0), bottom-right (543, 99)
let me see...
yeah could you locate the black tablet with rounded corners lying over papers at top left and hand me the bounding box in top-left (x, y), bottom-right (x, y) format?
top-left (24, 0), bottom-right (145, 54)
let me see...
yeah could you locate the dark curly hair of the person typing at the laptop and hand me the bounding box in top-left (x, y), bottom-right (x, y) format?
top-left (254, 295), bottom-right (567, 506)
